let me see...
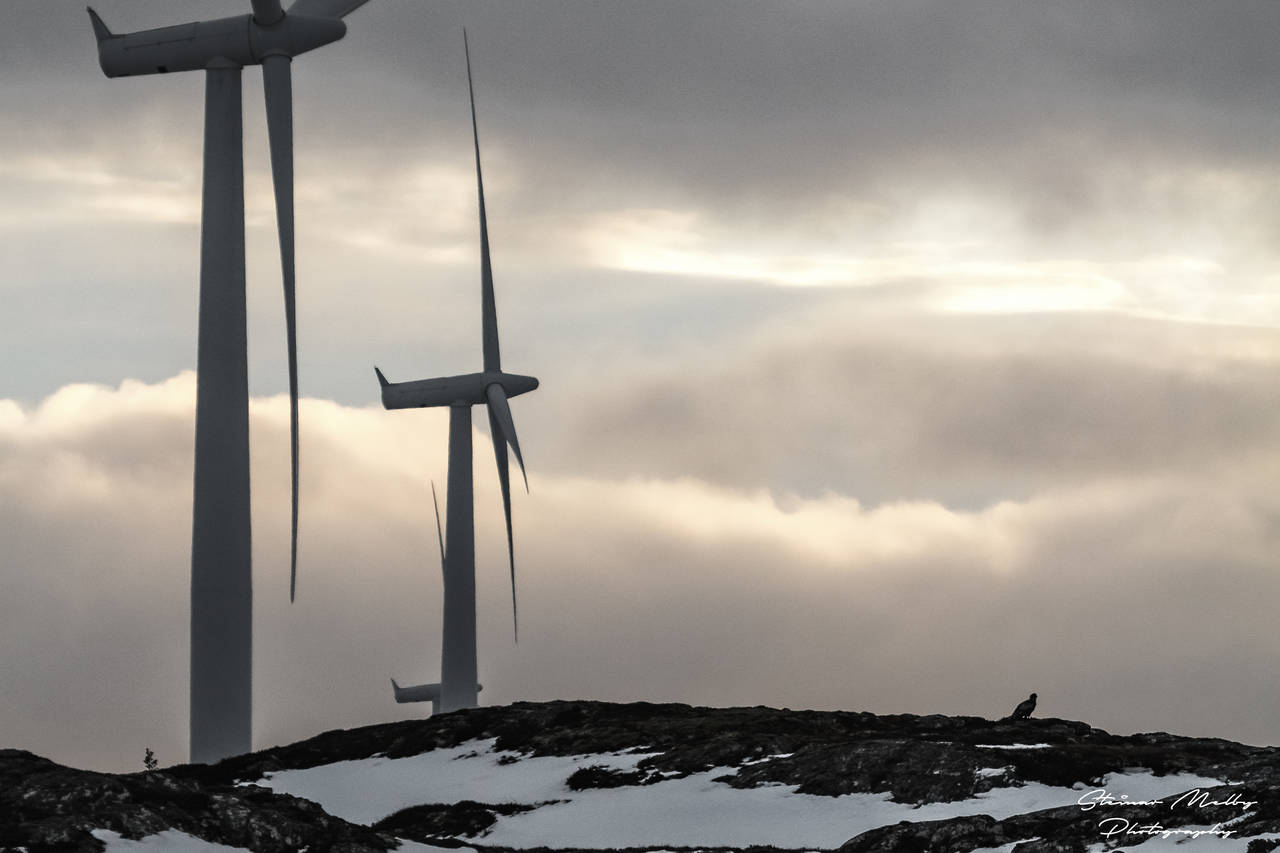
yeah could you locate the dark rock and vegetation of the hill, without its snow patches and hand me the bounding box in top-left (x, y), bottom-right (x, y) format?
top-left (0, 702), bottom-right (1280, 853)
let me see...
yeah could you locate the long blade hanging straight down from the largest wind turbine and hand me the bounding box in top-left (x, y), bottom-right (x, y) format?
top-left (262, 54), bottom-right (298, 602)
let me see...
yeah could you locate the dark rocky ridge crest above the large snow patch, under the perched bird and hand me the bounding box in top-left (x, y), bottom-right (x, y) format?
top-left (170, 702), bottom-right (1276, 803)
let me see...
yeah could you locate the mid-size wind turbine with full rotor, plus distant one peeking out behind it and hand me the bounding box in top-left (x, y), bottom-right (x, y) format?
top-left (374, 31), bottom-right (538, 712)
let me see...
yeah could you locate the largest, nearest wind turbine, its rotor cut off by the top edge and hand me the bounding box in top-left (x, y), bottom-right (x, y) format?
top-left (88, 0), bottom-right (366, 762)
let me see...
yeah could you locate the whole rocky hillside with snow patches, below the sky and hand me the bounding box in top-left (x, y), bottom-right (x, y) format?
top-left (0, 702), bottom-right (1280, 853)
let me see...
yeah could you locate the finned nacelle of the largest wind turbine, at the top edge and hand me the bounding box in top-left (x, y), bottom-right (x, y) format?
top-left (88, 9), bottom-right (347, 77)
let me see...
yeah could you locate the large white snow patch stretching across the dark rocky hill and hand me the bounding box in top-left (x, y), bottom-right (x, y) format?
top-left (259, 740), bottom-right (1222, 848)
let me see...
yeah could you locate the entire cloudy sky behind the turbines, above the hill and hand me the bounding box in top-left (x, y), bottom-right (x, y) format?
top-left (0, 0), bottom-right (1280, 770)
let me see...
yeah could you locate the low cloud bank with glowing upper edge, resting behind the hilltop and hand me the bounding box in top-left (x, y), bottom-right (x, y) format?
top-left (0, 374), bottom-right (1280, 768)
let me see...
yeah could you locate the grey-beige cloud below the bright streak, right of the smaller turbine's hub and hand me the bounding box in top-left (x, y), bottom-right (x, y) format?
top-left (542, 306), bottom-right (1280, 507)
